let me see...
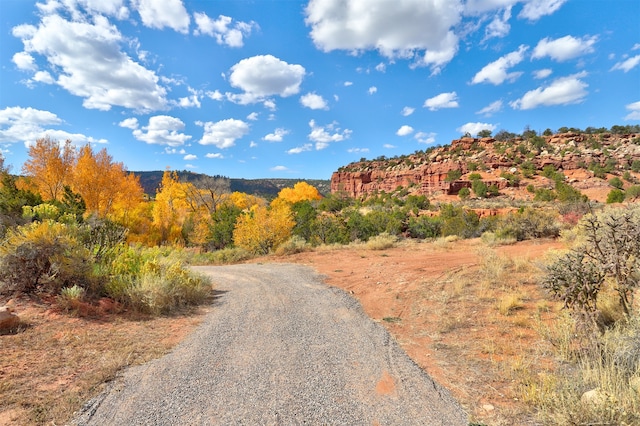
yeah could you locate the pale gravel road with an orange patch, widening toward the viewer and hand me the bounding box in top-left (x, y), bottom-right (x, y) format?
top-left (73, 264), bottom-right (468, 426)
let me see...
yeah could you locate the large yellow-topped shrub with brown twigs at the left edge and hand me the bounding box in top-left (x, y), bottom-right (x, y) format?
top-left (0, 220), bottom-right (93, 294)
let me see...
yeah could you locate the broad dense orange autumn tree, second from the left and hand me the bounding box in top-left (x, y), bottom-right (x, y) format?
top-left (71, 144), bottom-right (143, 218)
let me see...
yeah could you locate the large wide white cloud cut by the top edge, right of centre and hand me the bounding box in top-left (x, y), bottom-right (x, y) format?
top-left (305, 0), bottom-right (461, 73)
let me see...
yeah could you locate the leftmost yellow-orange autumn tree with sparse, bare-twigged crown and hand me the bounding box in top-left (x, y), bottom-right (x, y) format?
top-left (22, 136), bottom-right (75, 201)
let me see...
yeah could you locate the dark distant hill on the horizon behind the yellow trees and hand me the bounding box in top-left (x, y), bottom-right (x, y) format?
top-left (132, 170), bottom-right (331, 199)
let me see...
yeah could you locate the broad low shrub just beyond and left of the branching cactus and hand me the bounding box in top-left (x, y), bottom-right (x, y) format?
top-left (495, 207), bottom-right (560, 241)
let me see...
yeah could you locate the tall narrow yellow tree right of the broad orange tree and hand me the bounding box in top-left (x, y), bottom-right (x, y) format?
top-left (152, 170), bottom-right (191, 245)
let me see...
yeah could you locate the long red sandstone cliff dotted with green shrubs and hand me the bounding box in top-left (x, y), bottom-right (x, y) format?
top-left (331, 133), bottom-right (640, 198)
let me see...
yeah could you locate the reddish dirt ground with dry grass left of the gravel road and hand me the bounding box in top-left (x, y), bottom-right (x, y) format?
top-left (0, 301), bottom-right (206, 425)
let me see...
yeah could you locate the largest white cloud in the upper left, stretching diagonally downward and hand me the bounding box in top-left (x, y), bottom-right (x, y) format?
top-left (12, 15), bottom-right (167, 111)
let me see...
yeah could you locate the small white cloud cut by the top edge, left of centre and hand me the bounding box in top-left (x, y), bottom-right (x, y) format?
top-left (131, 0), bottom-right (190, 34)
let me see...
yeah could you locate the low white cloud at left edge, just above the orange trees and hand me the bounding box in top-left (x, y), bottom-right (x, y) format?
top-left (0, 107), bottom-right (107, 147)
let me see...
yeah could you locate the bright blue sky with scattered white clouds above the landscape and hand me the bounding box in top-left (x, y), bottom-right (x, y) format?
top-left (0, 0), bottom-right (640, 179)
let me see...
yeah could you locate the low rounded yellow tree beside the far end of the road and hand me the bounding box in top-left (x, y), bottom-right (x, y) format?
top-left (233, 202), bottom-right (295, 254)
